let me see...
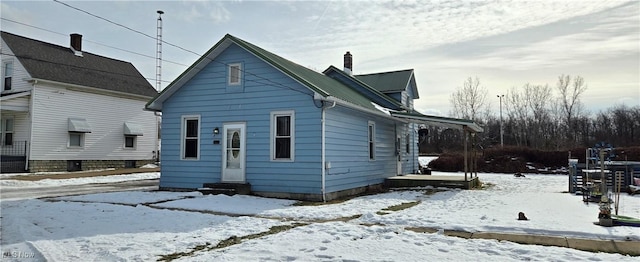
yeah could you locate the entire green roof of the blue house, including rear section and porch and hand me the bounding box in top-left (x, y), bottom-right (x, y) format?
top-left (146, 34), bottom-right (482, 132)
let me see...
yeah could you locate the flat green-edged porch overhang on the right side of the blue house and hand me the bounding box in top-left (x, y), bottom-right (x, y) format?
top-left (391, 112), bottom-right (484, 133)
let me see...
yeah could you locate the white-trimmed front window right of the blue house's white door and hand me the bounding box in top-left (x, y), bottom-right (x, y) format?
top-left (271, 111), bottom-right (295, 161)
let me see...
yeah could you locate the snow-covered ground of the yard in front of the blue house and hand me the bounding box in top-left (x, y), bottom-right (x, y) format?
top-left (0, 163), bottom-right (640, 261)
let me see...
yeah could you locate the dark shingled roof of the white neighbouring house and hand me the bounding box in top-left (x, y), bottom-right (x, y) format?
top-left (2, 31), bottom-right (157, 97)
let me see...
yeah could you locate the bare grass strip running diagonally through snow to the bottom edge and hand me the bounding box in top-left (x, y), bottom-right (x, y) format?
top-left (157, 223), bottom-right (308, 261)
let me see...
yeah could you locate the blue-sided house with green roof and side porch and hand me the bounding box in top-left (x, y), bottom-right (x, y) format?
top-left (146, 35), bottom-right (481, 201)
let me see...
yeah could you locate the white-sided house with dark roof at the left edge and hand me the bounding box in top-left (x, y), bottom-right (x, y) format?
top-left (0, 32), bottom-right (158, 172)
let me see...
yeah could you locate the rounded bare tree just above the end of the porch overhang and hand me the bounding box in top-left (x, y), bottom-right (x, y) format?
top-left (449, 77), bottom-right (488, 122)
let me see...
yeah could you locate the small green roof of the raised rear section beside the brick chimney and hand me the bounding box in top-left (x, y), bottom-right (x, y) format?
top-left (354, 69), bottom-right (419, 98)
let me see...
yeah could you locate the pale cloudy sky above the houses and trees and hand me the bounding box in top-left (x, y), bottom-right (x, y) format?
top-left (0, 0), bottom-right (640, 115)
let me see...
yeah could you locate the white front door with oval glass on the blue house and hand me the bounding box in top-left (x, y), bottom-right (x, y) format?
top-left (222, 123), bottom-right (246, 183)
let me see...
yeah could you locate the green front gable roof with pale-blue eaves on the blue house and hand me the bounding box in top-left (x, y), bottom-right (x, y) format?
top-left (147, 34), bottom-right (400, 111)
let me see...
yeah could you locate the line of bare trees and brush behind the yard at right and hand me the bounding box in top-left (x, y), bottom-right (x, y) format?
top-left (419, 75), bottom-right (640, 153)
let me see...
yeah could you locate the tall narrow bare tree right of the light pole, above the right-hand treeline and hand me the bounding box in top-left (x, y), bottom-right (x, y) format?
top-left (557, 75), bottom-right (587, 146)
